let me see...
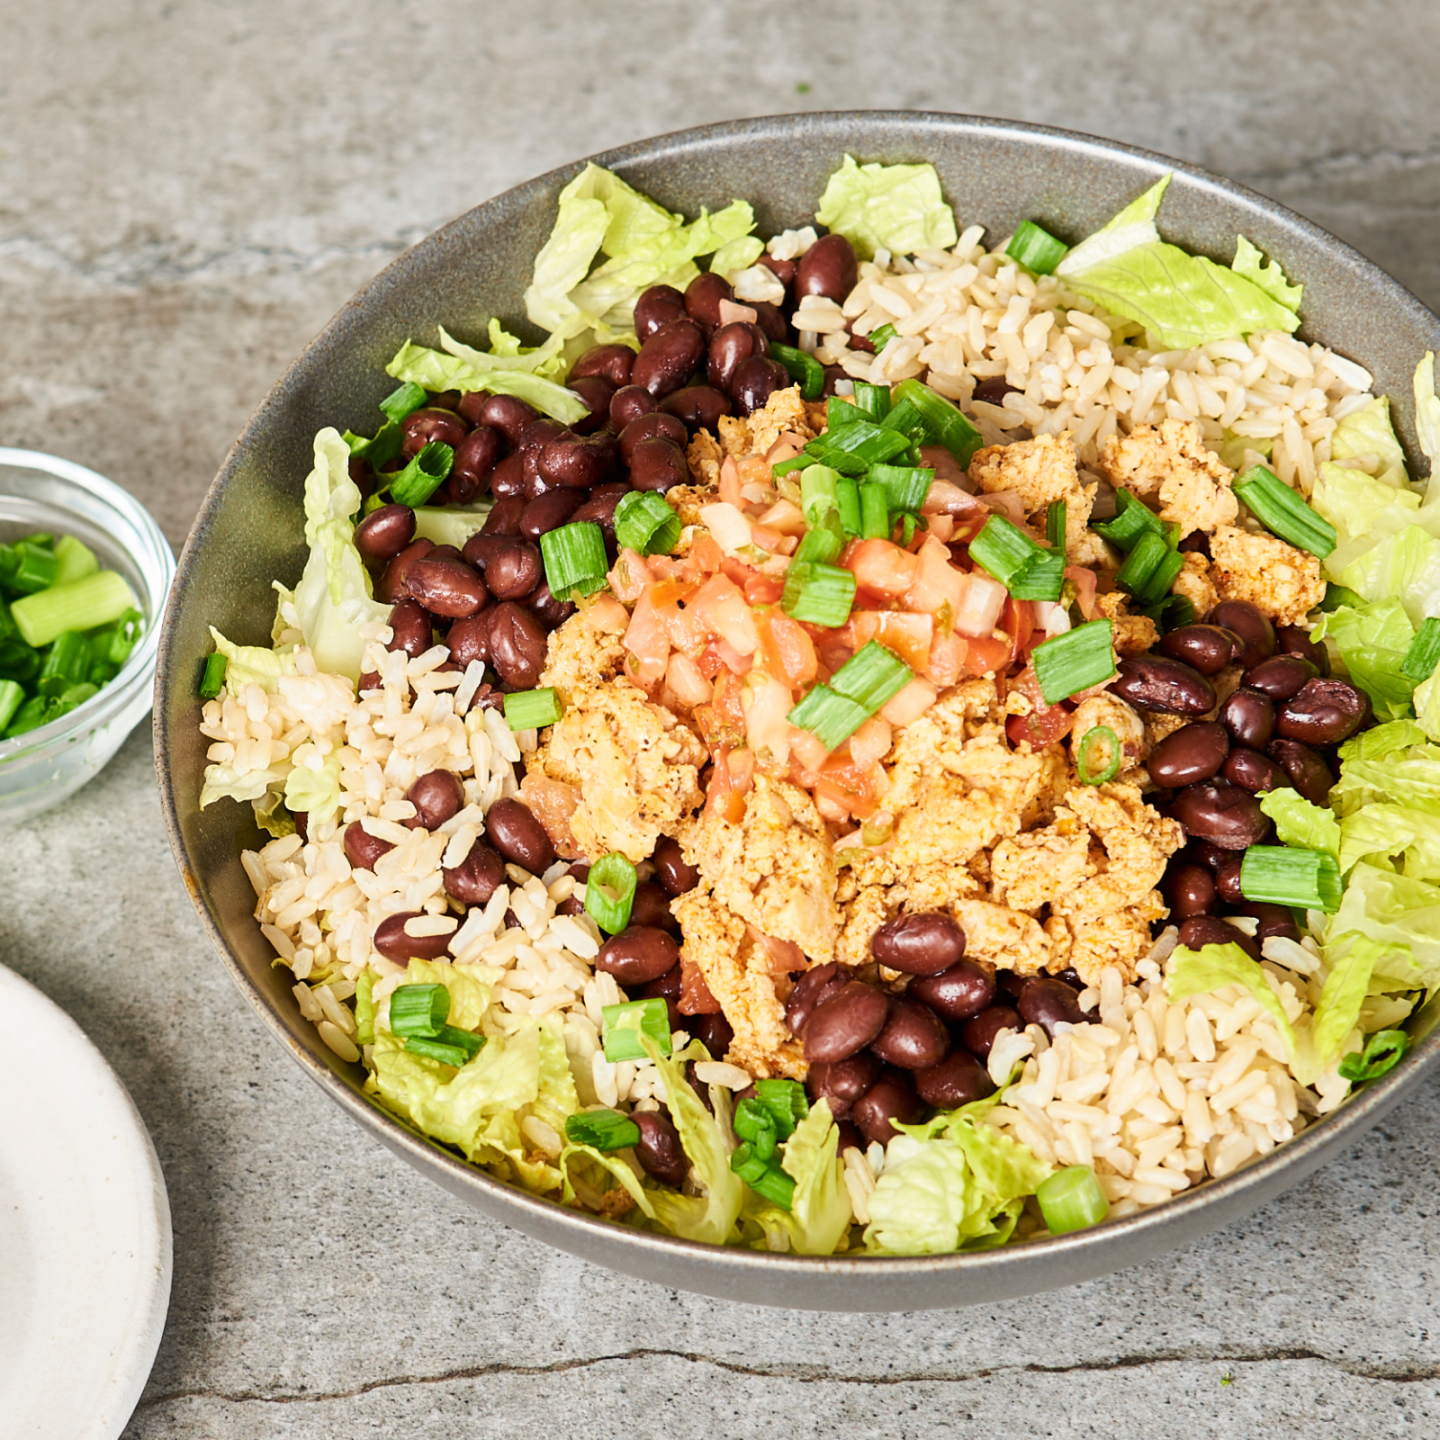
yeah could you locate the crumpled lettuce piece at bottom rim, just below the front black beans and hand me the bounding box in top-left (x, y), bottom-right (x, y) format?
top-left (865, 1093), bottom-right (1053, 1254)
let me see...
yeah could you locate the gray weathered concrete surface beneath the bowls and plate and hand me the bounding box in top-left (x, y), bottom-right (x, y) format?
top-left (0, 0), bottom-right (1440, 1440)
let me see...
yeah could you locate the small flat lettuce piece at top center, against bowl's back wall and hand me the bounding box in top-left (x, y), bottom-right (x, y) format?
top-left (815, 156), bottom-right (959, 261)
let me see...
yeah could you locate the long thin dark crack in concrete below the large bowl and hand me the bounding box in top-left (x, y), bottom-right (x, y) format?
top-left (135, 1348), bottom-right (1440, 1414)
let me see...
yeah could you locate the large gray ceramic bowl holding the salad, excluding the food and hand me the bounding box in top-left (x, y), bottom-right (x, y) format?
top-left (156, 112), bottom-right (1440, 1310)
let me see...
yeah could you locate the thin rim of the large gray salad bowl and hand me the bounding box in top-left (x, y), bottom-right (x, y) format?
top-left (154, 109), bottom-right (1440, 1290)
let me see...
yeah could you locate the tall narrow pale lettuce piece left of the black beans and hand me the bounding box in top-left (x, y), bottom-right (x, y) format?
top-left (295, 425), bottom-right (390, 681)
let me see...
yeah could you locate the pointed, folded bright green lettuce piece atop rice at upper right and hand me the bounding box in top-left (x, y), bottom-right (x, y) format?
top-left (1056, 176), bottom-right (1300, 350)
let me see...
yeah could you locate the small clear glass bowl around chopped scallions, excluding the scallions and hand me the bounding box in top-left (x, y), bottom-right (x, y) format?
top-left (0, 446), bottom-right (176, 828)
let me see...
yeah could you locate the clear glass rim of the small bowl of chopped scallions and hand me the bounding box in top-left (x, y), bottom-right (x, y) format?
top-left (0, 445), bottom-right (177, 766)
